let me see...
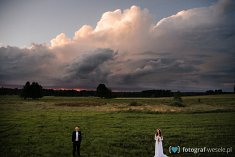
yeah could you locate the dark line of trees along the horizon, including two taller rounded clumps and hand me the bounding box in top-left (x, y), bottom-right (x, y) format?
top-left (0, 82), bottom-right (235, 99)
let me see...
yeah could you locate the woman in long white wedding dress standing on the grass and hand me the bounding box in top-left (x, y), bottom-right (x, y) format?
top-left (154, 129), bottom-right (167, 157)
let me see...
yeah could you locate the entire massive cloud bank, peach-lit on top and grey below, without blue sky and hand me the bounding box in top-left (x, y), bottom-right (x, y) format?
top-left (0, 0), bottom-right (235, 90)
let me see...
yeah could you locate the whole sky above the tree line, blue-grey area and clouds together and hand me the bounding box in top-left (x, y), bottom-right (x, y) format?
top-left (0, 0), bottom-right (235, 91)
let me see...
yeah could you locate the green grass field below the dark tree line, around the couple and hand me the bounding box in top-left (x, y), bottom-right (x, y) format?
top-left (0, 94), bottom-right (235, 157)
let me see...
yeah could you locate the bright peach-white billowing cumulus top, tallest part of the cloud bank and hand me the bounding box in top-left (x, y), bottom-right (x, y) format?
top-left (51, 6), bottom-right (153, 53)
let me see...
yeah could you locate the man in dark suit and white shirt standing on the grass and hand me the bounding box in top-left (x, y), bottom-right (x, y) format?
top-left (72, 126), bottom-right (82, 156)
